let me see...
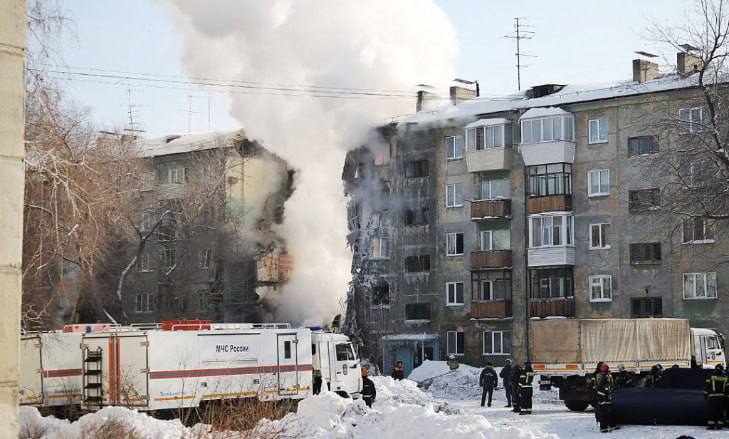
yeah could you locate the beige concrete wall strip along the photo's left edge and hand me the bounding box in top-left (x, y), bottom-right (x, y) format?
top-left (0, 0), bottom-right (26, 437)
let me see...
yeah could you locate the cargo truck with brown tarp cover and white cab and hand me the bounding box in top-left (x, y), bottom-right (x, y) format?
top-left (529, 319), bottom-right (726, 410)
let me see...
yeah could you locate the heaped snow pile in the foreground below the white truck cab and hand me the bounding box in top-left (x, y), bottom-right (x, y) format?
top-left (257, 377), bottom-right (556, 439)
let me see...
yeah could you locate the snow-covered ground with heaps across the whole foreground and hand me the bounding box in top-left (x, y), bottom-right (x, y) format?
top-left (21, 362), bottom-right (727, 439)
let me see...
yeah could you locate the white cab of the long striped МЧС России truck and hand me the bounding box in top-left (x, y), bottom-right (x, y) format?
top-left (311, 329), bottom-right (362, 398)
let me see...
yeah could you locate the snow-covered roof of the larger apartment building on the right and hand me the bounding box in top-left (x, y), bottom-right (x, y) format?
top-left (395, 74), bottom-right (712, 123)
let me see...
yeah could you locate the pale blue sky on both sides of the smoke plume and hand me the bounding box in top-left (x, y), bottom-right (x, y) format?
top-left (48, 0), bottom-right (693, 137)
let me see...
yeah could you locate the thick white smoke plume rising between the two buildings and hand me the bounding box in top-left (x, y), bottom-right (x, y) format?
top-left (168, 0), bottom-right (458, 324)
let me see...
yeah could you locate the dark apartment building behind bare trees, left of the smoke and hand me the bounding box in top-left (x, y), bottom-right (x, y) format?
top-left (109, 130), bottom-right (293, 323)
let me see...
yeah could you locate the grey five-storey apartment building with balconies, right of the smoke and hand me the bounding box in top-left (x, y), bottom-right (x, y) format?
top-left (343, 53), bottom-right (729, 373)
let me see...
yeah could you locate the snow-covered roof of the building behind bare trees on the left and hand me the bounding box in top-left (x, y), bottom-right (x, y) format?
top-left (137, 130), bottom-right (244, 157)
